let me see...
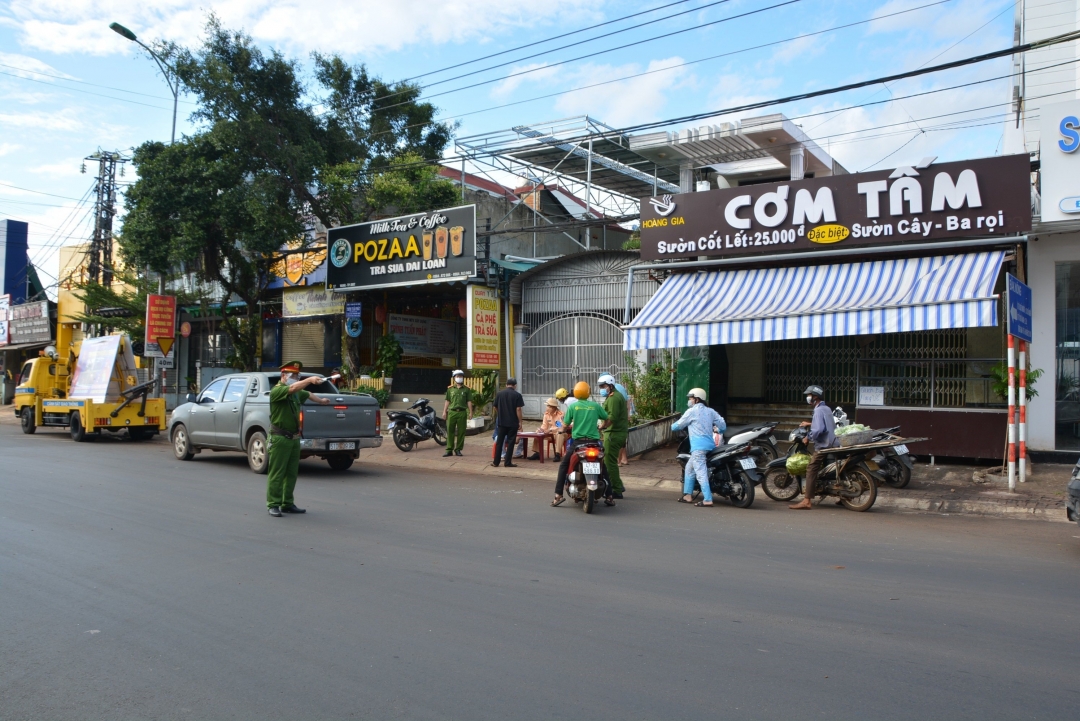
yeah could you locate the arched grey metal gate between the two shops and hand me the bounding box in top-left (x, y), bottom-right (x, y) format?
top-left (519, 315), bottom-right (627, 395)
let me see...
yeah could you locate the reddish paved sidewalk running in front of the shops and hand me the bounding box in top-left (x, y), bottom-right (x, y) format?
top-left (359, 427), bottom-right (1072, 522)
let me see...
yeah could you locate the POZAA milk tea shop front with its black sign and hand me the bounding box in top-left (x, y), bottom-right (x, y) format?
top-left (326, 205), bottom-right (509, 395)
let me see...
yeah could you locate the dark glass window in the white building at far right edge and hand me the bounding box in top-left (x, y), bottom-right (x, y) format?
top-left (1054, 262), bottom-right (1080, 450)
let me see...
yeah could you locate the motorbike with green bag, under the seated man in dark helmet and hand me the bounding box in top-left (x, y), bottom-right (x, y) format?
top-left (761, 427), bottom-right (877, 511)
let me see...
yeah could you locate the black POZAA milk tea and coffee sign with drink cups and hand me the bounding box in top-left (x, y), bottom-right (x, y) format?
top-left (326, 205), bottom-right (476, 291)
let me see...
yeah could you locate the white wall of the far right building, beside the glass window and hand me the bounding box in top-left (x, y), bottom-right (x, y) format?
top-left (1027, 233), bottom-right (1080, 450)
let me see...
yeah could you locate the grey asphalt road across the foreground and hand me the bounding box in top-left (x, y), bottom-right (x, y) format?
top-left (6, 425), bottom-right (1080, 720)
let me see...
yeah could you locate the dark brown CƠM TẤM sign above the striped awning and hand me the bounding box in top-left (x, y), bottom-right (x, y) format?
top-left (642, 155), bottom-right (1031, 260)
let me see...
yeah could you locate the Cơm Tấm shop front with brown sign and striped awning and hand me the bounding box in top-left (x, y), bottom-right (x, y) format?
top-left (625, 155), bottom-right (1031, 458)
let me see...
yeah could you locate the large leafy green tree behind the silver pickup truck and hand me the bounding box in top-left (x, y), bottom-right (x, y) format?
top-left (121, 16), bottom-right (453, 370)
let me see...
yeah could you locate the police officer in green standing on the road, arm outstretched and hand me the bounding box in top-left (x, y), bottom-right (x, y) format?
top-left (267, 361), bottom-right (329, 518)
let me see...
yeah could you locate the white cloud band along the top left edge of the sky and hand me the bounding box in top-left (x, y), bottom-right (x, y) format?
top-left (9, 0), bottom-right (598, 56)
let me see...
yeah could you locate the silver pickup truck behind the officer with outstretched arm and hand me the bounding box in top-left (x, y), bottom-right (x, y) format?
top-left (168, 373), bottom-right (382, 473)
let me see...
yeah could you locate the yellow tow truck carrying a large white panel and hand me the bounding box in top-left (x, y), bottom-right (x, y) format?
top-left (15, 323), bottom-right (165, 443)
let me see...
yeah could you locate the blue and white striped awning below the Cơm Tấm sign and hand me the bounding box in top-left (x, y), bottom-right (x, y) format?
top-left (624, 250), bottom-right (1005, 351)
